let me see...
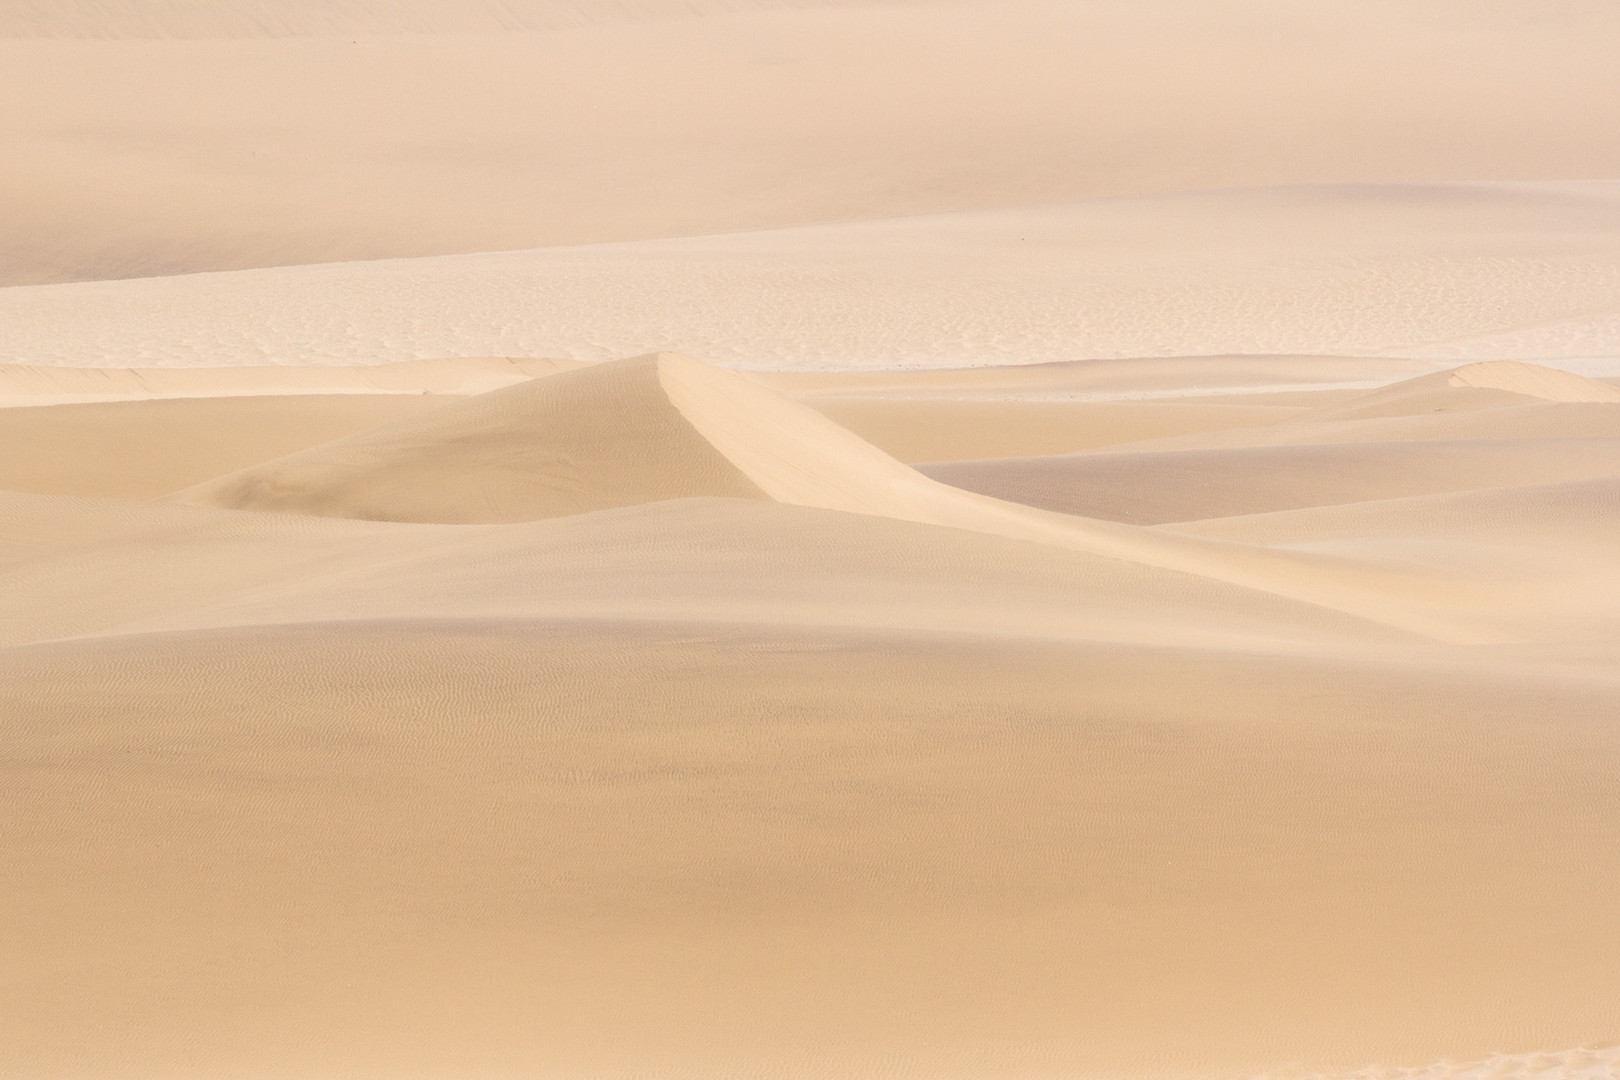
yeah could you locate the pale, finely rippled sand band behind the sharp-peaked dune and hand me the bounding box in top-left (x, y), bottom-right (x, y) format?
top-left (0, 186), bottom-right (1620, 372)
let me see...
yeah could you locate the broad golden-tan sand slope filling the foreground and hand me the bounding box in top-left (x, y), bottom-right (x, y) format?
top-left (0, 620), bottom-right (1620, 1077)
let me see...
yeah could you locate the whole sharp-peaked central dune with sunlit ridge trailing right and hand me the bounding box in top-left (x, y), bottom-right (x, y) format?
top-left (173, 353), bottom-right (1502, 643)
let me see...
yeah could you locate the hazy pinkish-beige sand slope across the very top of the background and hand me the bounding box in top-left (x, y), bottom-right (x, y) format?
top-left (0, 0), bottom-right (1620, 284)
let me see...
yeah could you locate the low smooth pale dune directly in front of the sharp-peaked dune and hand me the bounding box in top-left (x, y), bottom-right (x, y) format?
top-left (0, 494), bottom-right (1413, 651)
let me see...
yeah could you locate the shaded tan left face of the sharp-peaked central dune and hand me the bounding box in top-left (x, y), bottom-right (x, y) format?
top-left (178, 356), bottom-right (763, 523)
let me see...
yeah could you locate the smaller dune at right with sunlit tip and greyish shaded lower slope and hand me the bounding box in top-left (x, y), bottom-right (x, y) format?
top-left (922, 361), bottom-right (1620, 525)
